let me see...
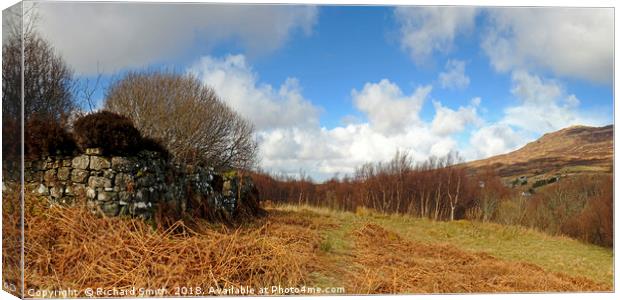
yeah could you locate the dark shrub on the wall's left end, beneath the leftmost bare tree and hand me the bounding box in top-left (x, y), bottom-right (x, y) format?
top-left (24, 116), bottom-right (77, 159)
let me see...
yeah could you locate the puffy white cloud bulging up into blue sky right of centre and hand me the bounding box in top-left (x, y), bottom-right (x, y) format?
top-left (351, 79), bottom-right (432, 134)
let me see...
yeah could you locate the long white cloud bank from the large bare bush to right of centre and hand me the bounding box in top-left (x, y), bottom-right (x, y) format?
top-left (188, 55), bottom-right (472, 180)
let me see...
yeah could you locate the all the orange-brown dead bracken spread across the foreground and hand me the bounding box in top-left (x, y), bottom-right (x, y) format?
top-left (3, 193), bottom-right (611, 297)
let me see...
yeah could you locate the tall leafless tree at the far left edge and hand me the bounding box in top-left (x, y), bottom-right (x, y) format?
top-left (2, 4), bottom-right (76, 178)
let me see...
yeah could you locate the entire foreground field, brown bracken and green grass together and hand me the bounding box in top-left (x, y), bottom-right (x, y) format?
top-left (4, 197), bottom-right (613, 296)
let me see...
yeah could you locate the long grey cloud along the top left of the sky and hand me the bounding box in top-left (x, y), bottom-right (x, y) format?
top-left (36, 2), bottom-right (317, 74)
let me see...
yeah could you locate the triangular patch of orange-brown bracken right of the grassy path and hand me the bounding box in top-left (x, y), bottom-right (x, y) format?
top-left (350, 224), bottom-right (611, 294)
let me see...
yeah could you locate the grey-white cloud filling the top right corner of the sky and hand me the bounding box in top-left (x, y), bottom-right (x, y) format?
top-left (482, 7), bottom-right (614, 83)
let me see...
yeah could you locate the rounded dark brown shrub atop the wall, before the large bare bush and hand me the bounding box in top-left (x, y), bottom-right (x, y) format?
top-left (73, 111), bottom-right (142, 154)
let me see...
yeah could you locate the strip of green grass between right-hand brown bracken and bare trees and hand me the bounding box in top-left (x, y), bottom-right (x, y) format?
top-left (274, 206), bottom-right (613, 287)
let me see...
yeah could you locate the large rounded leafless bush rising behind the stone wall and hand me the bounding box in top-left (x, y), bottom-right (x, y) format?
top-left (104, 72), bottom-right (257, 169)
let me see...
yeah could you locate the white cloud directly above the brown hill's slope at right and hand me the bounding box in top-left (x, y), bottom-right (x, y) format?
top-left (465, 71), bottom-right (611, 159)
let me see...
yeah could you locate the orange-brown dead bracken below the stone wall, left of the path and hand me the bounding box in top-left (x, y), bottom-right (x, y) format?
top-left (25, 196), bottom-right (319, 296)
